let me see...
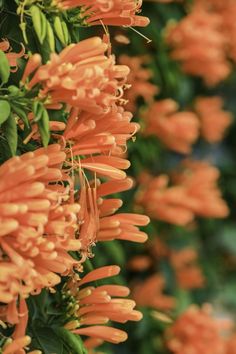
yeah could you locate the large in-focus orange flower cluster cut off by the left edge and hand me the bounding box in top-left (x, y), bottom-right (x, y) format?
top-left (0, 144), bottom-right (81, 310)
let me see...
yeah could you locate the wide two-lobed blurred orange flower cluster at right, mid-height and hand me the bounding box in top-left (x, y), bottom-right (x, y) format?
top-left (136, 161), bottom-right (229, 225)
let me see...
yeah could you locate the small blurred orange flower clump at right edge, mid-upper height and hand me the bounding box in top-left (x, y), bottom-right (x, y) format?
top-left (195, 97), bottom-right (232, 143)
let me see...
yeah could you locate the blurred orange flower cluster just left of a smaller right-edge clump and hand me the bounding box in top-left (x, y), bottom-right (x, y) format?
top-left (143, 99), bottom-right (200, 154)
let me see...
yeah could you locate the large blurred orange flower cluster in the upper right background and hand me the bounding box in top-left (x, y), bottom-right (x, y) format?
top-left (166, 6), bottom-right (231, 86)
